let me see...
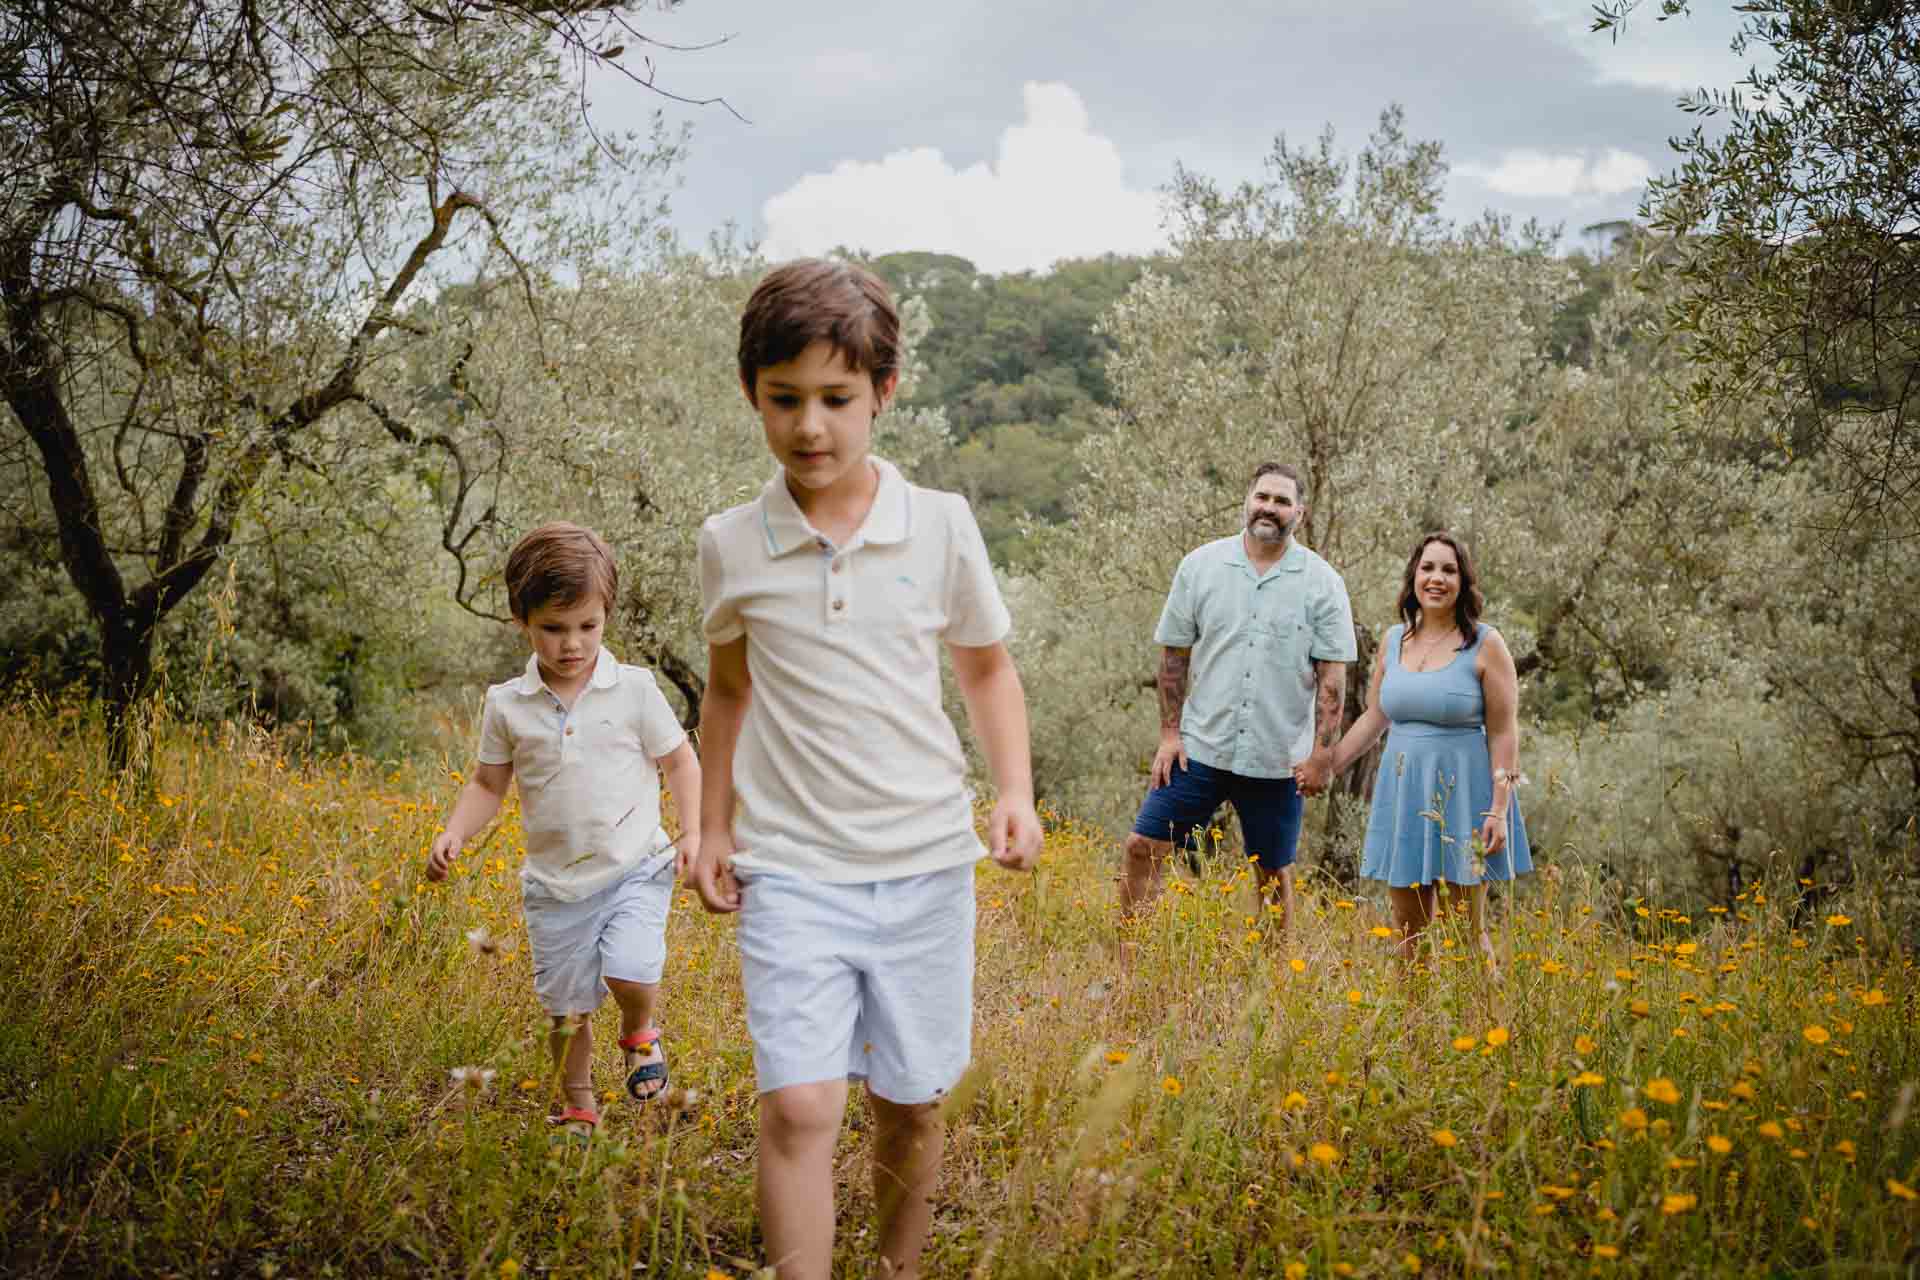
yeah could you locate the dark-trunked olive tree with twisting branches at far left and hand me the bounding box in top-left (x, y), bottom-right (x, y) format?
top-left (0, 0), bottom-right (702, 764)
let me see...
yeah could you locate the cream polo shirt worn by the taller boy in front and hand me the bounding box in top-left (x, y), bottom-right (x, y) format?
top-left (701, 459), bottom-right (1012, 883)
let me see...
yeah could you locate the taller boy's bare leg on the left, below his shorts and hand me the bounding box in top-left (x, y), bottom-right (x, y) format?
top-left (756, 1080), bottom-right (847, 1280)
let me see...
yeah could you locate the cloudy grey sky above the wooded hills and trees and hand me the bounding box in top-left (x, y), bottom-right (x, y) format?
top-left (589, 0), bottom-right (1745, 271)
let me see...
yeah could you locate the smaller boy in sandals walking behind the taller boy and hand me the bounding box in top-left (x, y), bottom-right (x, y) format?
top-left (426, 522), bottom-right (701, 1138)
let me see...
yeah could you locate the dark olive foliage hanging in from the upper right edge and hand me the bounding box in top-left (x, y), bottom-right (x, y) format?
top-left (1594, 0), bottom-right (1920, 537)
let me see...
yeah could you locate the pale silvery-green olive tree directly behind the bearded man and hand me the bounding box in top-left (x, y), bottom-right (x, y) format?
top-left (1023, 109), bottom-right (1569, 859)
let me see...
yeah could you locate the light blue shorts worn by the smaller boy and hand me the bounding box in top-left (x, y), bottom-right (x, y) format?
top-left (520, 860), bottom-right (674, 1017)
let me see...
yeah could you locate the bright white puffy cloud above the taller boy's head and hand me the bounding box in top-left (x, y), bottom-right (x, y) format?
top-left (762, 81), bottom-right (1165, 273)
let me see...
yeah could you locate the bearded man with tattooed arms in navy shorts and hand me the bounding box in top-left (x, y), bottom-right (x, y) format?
top-left (1119, 462), bottom-right (1359, 929)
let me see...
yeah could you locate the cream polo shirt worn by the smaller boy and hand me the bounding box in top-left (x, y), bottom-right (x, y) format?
top-left (480, 649), bottom-right (687, 902)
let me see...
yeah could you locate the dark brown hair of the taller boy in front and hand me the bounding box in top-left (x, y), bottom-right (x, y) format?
top-left (739, 257), bottom-right (900, 403)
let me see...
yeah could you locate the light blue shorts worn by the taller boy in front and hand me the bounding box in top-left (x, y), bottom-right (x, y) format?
top-left (735, 864), bottom-right (973, 1103)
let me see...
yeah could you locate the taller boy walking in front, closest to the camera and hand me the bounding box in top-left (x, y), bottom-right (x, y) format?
top-left (693, 261), bottom-right (1041, 1280)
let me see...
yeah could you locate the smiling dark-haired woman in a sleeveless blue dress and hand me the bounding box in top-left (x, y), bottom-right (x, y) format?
top-left (1332, 532), bottom-right (1534, 961)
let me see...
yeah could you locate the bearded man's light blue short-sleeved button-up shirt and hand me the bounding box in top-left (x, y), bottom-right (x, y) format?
top-left (1154, 533), bottom-right (1359, 777)
